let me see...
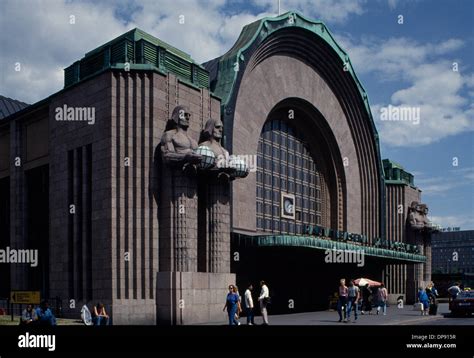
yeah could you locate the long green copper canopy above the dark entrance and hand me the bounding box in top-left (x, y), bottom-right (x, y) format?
top-left (232, 234), bottom-right (426, 263)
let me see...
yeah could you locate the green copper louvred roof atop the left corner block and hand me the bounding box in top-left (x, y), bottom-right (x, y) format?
top-left (64, 29), bottom-right (209, 88)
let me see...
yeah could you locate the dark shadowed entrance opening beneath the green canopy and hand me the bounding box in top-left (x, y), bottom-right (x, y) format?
top-left (231, 245), bottom-right (384, 314)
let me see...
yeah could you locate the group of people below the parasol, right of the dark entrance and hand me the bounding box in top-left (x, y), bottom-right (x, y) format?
top-left (337, 279), bottom-right (388, 323)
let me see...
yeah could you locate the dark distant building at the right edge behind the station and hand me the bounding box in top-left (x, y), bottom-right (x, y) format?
top-left (431, 230), bottom-right (474, 274)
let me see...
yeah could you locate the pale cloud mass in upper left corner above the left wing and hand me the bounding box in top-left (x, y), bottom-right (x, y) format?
top-left (0, 0), bottom-right (133, 103)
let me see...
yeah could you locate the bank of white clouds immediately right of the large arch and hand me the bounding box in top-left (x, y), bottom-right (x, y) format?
top-left (341, 37), bottom-right (474, 146)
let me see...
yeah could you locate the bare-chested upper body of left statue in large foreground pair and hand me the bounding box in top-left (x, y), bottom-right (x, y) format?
top-left (161, 106), bottom-right (202, 166)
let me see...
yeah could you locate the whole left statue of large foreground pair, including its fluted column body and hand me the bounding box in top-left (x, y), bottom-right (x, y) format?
top-left (157, 106), bottom-right (202, 272)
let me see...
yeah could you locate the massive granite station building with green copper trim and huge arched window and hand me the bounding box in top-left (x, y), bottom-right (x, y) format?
top-left (0, 12), bottom-right (431, 324)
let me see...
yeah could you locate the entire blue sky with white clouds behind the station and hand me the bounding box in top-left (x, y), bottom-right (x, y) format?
top-left (0, 0), bottom-right (474, 230)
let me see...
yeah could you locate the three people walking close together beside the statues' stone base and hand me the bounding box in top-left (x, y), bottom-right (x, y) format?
top-left (223, 281), bottom-right (270, 326)
